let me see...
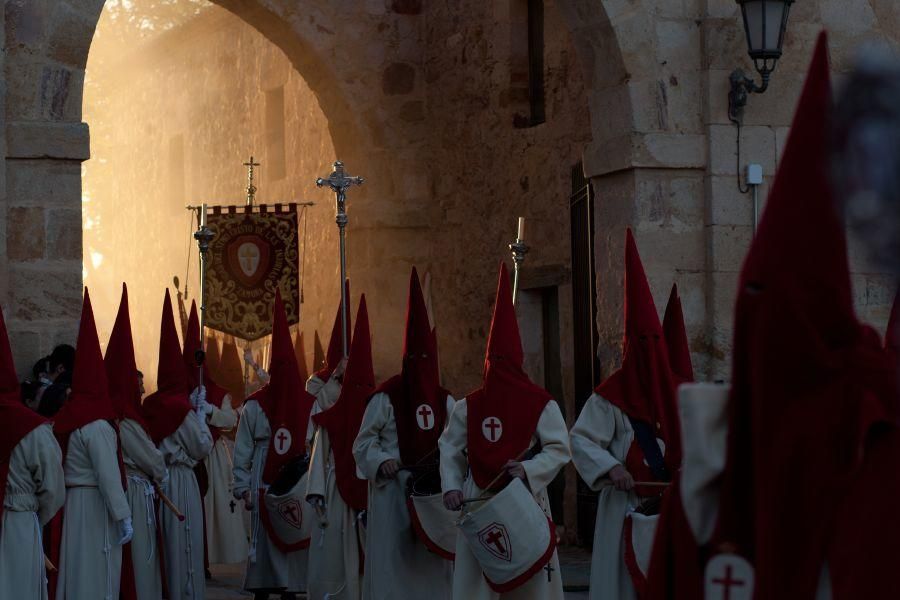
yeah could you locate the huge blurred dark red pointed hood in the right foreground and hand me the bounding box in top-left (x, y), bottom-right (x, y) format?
top-left (715, 34), bottom-right (893, 600)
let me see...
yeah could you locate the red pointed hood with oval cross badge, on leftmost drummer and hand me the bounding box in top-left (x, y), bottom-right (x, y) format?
top-left (249, 289), bottom-right (316, 483)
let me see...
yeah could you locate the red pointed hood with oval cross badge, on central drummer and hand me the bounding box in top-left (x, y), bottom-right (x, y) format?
top-left (466, 263), bottom-right (552, 488)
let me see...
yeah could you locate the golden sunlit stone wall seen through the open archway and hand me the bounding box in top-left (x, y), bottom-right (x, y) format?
top-left (82, 6), bottom-right (339, 389)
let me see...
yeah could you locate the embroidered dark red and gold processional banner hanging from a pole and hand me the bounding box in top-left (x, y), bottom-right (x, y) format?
top-left (206, 204), bottom-right (300, 341)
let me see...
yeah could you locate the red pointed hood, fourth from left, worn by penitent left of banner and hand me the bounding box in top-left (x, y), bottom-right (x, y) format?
top-left (144, 290), bottom-right (191, 444)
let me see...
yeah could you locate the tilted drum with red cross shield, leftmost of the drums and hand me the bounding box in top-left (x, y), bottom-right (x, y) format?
top-left (259, 458), bottom-right (316, 553)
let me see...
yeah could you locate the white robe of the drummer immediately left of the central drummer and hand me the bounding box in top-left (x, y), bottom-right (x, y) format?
top-left (353, 393), bottom-right (454, 600)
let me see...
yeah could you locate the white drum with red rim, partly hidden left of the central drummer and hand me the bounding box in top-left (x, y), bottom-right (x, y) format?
top-left (406, 466), bottom-right (459, 560)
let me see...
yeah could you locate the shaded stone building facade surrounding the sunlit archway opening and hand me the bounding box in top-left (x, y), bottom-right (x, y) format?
top-left (0, 0), bottom-right (900, 418)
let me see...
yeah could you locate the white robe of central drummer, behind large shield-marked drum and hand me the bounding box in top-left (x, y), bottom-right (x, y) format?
top-left (439, 399), bottom-right (570, 600)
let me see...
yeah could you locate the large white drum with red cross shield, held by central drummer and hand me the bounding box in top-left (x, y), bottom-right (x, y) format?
top-left (457, 479), bottom-right (556, 594)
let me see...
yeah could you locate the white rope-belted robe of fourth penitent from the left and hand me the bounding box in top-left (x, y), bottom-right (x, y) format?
top-left (159, 411), bottom-right (212, 600)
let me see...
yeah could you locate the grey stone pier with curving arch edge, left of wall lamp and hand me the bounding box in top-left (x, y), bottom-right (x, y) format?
top-left (559, 0), bottom-right (708, 374)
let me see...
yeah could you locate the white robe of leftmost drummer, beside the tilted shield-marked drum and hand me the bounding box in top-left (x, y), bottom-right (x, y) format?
top-left (234, 400), bottom-right (309, 593)
